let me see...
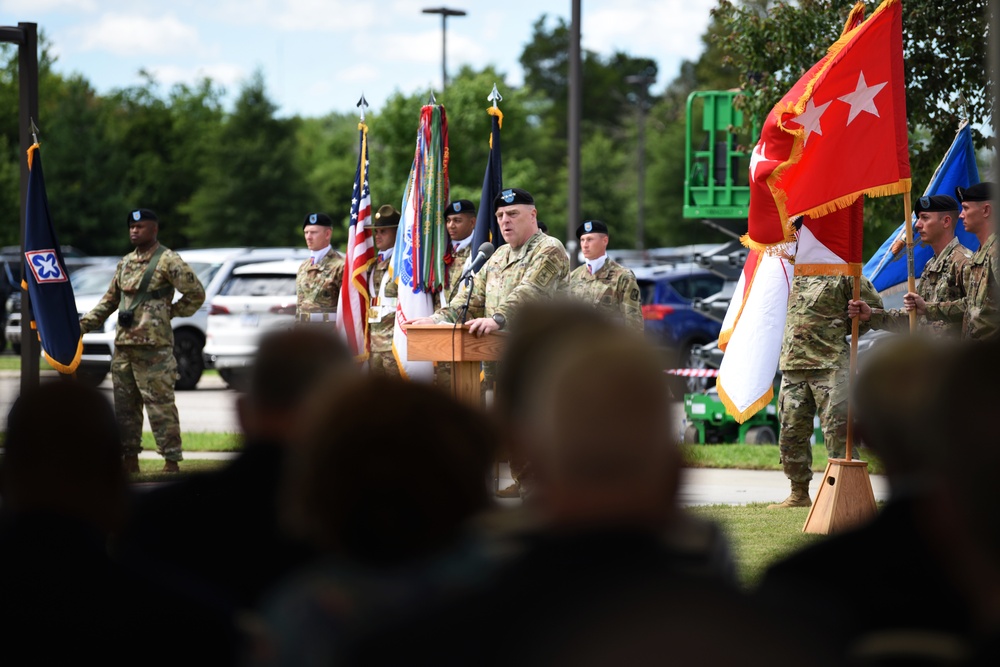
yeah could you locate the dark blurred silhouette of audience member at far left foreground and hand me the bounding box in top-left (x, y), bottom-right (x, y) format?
top-left (0, 381), bottom-right (235, 665)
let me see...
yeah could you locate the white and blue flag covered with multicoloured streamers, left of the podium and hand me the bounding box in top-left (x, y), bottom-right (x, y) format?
top-left (389, 104), bottom-right (448, 381)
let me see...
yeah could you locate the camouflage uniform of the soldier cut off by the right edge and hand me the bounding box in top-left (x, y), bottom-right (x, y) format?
top-left (925, 234), bottom-right (1000, 340)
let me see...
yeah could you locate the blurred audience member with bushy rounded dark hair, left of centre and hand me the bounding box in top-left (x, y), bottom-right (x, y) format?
top-left (248, 376), bottom-right (496, 667)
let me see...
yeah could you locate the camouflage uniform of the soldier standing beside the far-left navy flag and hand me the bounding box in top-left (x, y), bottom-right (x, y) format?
top-left (80, 248), bottom-right (205, 461)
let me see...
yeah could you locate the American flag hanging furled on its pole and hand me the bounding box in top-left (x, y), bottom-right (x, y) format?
top-left (337, 122), bottom-right (375, 361)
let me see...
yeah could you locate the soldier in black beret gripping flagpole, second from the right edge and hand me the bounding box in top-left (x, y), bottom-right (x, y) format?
top-left (847, 195), bottom-right (972, 336)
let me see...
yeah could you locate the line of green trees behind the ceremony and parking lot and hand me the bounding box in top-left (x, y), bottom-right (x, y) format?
top-left (0, 0), bottom-right (987, 255)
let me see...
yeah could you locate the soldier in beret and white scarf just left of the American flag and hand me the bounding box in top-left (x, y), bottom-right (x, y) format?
top-left (295, 213), bottom-right (344, 323)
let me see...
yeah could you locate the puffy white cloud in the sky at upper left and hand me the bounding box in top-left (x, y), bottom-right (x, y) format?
top-left (70, 14), bottom-right (199, 56)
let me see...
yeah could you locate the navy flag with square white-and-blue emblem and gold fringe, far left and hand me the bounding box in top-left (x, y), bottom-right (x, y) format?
top-left (21, 144), bottom-right (83, 374)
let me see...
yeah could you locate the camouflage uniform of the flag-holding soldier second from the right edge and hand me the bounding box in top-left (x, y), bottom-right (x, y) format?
top-left (869, 237), bottom-right (972, 336)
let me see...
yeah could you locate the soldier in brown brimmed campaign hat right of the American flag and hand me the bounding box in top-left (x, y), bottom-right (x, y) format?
top-left (368, 204), bottom-right (399, 376)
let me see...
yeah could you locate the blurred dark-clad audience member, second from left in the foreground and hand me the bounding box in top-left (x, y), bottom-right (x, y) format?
top-left (121, 327), bottom-right (353, 608)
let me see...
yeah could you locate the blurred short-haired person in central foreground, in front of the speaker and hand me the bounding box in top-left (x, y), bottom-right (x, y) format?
top-left (342, 310), bottom-right (810, 665)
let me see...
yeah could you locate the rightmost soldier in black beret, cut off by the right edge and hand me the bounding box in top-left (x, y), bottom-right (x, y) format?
top-left (903, 183), bottom-right (1000, 340)
